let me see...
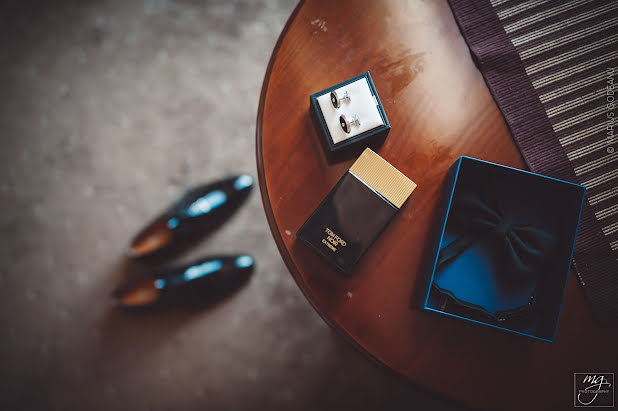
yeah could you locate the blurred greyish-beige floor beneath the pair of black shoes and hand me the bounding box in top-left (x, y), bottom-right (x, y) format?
top-left (0, 0), bottom-right (460, 410)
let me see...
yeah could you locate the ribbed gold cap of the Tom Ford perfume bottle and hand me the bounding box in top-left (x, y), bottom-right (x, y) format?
top-left (350, 148), bottom-right (416, 208)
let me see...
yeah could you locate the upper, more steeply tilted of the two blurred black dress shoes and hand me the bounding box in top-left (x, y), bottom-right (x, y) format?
top-left (127, 174), bottom-right (253, 261)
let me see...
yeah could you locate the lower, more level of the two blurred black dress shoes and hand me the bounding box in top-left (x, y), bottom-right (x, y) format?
top-left (112, 254), bottom-right (255, 311)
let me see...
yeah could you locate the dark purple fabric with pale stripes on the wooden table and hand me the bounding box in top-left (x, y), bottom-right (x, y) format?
top-left (449, 0), bottom-right (618, 325)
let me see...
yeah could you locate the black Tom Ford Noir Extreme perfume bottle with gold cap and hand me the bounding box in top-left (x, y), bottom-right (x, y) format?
top-left (296, 148), bottom-right (416, 274)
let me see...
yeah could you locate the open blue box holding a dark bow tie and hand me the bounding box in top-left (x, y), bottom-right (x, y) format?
top-left (420, 156), bottom-right (586, 342)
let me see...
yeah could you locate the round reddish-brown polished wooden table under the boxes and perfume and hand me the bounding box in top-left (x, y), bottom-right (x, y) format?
top-left (257, 0), bottom-right (618, 409)
